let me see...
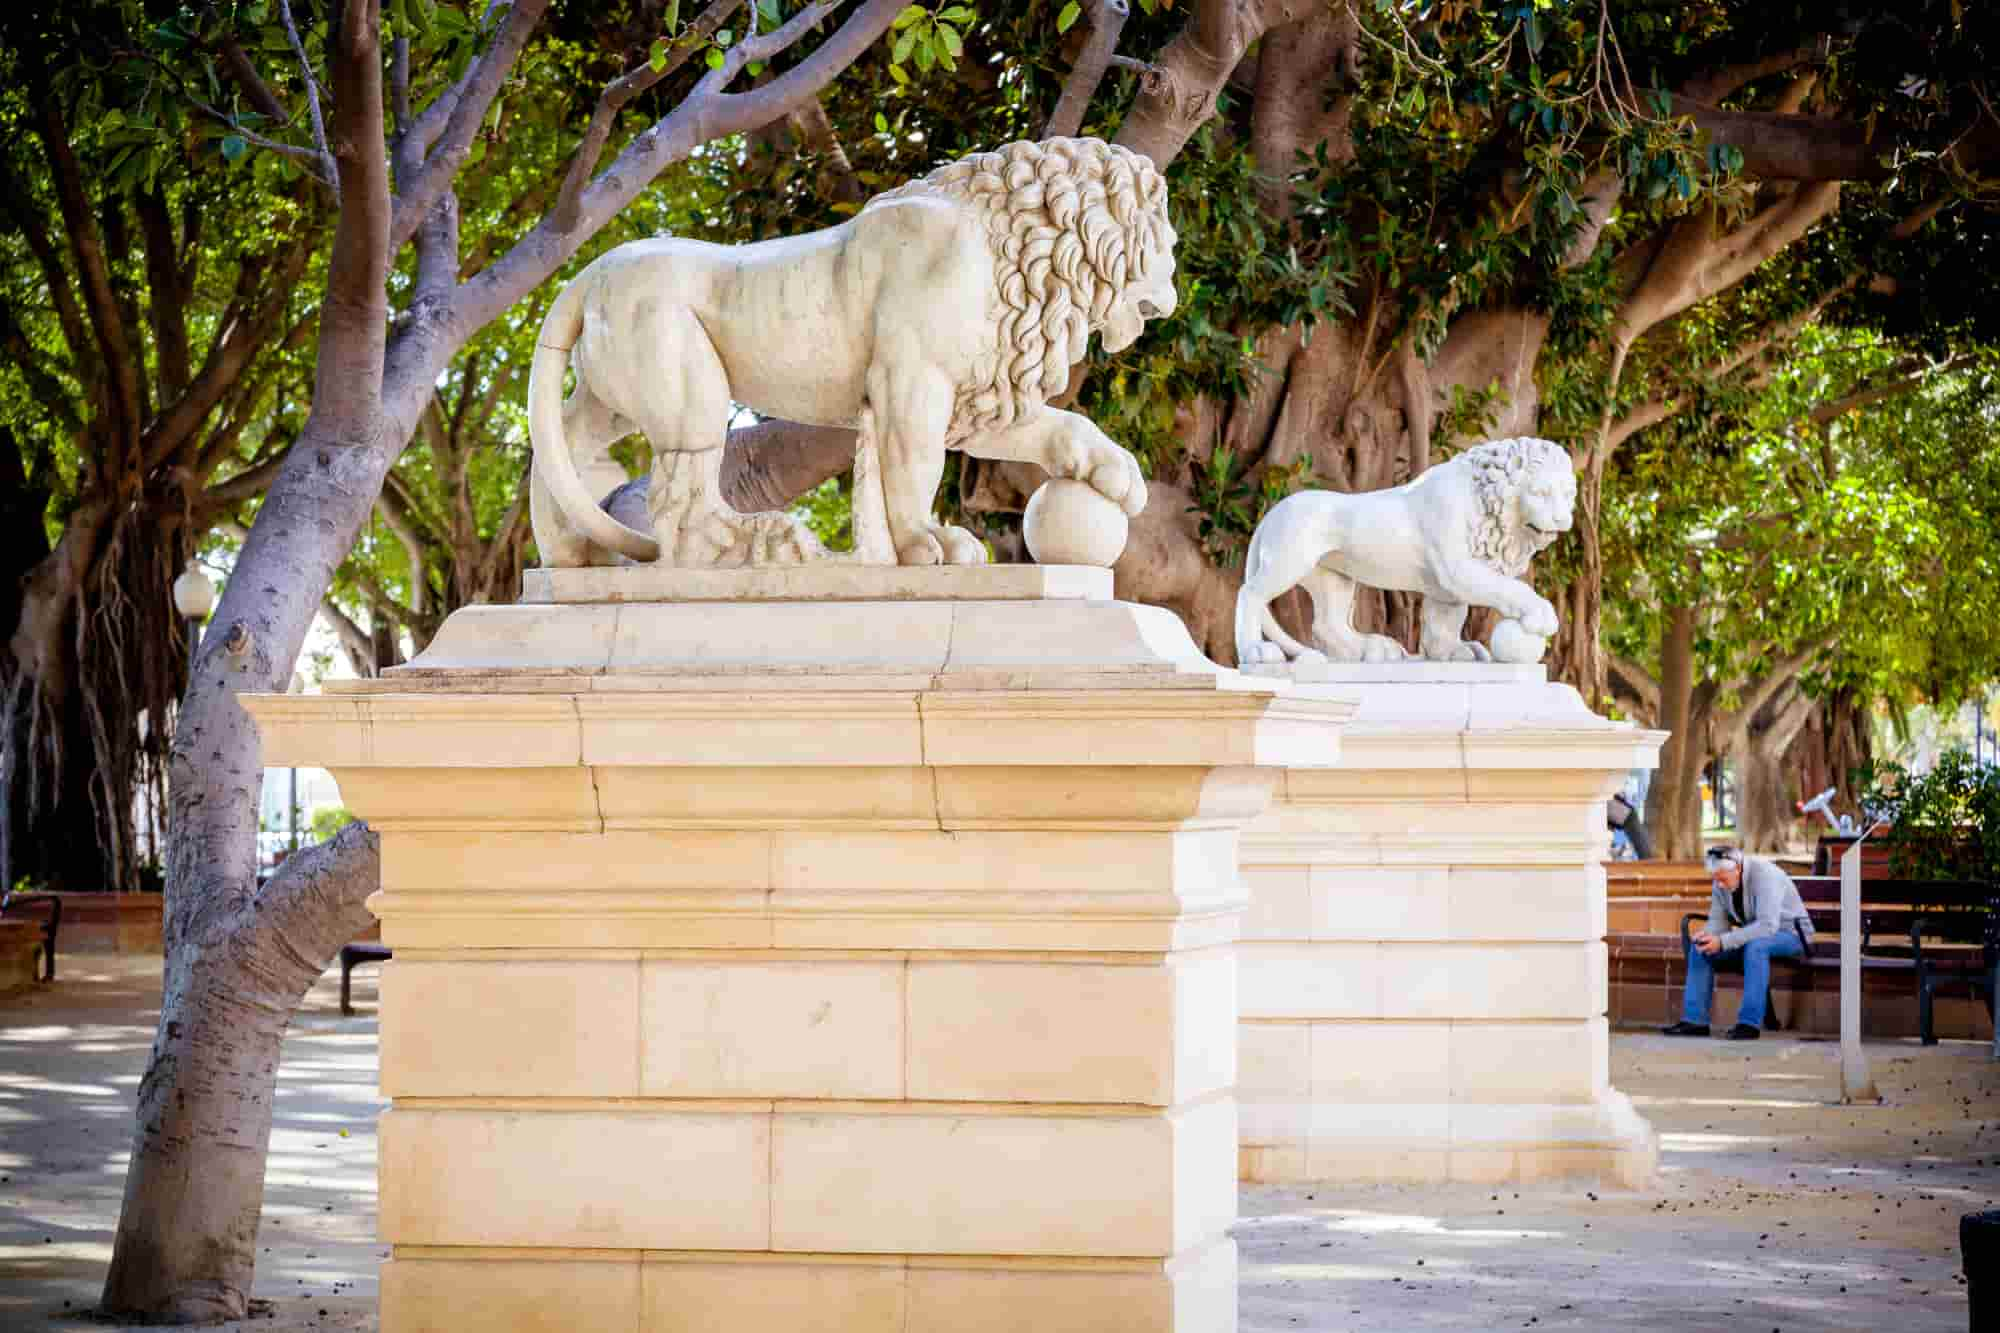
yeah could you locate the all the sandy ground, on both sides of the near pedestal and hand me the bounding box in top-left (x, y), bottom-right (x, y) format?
top-left (0, 959), bottom-right (2000, 1333)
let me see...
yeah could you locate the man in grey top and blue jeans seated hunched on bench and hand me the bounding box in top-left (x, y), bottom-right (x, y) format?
top-left (1660, 847), bottom-right (1812, 1041)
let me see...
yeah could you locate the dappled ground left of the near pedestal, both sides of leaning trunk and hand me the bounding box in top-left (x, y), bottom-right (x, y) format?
top-left (0, 957), bottom-right (384, 1333)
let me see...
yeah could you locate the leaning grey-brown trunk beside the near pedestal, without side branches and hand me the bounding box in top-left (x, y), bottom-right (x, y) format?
top-left (104, 0), bottom-right (402, 1323)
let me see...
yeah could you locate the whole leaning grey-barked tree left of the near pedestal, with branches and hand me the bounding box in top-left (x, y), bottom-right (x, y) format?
top-left (104, 0), bottom-right (920, 1321)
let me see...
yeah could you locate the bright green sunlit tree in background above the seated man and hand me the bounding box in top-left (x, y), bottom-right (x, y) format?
top-left (1604, 324), bottom-right (2000, 857)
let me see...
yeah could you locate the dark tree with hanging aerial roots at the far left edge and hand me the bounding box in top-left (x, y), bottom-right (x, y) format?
top-left (0, 0), bottom-right (328, 889)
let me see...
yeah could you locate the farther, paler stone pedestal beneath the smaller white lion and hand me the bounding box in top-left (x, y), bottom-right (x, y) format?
top-left (1238, 662), bottom-right (1664, 1187)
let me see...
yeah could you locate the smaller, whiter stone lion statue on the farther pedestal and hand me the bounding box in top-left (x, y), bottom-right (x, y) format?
top-left (1236, 436), bottom-right (1576, 667)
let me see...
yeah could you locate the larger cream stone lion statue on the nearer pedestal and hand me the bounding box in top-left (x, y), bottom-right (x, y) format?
top-left (528, 138), bottom-right (1176, 566)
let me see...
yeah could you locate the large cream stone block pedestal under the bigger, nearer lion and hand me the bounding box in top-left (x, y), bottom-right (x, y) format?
top-left (246, 570), bottom-right (1348, 1333)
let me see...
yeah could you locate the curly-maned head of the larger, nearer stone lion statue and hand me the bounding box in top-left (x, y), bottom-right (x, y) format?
top-left (868, 138), bottom-right (1174, 436)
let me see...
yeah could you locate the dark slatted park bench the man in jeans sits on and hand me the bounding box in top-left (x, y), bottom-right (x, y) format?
top-left (1680, 875), bottom-right (2000, 1047)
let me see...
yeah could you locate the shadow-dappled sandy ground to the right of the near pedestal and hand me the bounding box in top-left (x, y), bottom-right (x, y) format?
top-left (1236, 1035), bottom-right (2000, 1333)
